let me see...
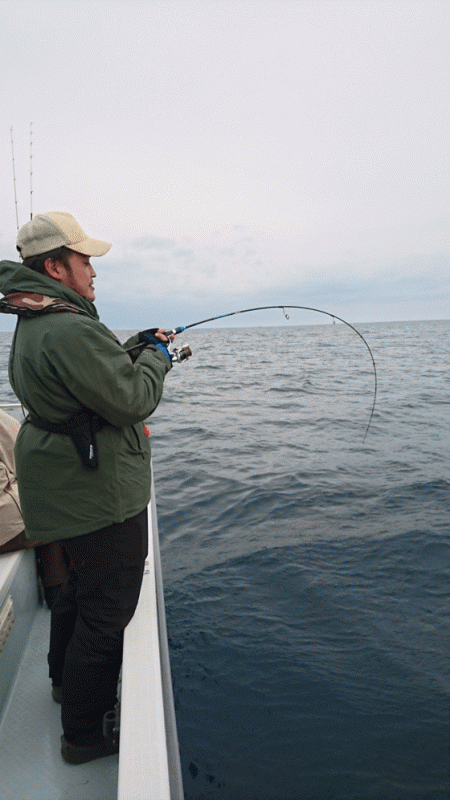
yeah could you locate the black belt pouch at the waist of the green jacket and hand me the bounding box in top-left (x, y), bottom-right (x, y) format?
top-left (27, 409), bottom-right (109, 469)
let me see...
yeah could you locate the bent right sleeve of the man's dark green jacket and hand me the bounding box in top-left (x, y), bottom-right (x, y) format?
top-left (40, 314), bottom-right (172, 428)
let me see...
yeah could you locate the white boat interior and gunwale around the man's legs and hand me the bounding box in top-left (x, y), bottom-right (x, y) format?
top-left (0, 476), bottom-right (183, 800)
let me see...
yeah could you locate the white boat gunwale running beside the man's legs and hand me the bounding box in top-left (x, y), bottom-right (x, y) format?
top-left (118, 480), bottom-right (184, 800)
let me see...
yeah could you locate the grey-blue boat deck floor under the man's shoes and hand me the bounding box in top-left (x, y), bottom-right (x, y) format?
top-left (0, 607), bottom-right (119, 800)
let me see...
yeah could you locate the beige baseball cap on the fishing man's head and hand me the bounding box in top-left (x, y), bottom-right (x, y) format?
top-left (17, 211), bottom-right (111, 258)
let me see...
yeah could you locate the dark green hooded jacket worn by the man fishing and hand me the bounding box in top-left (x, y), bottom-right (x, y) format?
top-left (0, 261), bottom-right (172, 542)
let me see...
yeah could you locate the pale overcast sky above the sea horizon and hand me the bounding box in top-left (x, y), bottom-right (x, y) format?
top-left (0, 0), bottom-right (450, 330)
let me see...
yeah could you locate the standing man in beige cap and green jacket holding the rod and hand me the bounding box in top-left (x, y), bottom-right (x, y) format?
top-left (0, 212), bottom-right (172, 764)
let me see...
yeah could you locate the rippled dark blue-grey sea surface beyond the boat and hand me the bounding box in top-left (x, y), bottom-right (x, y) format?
top-left (0, 321), bottom-right (450, 800)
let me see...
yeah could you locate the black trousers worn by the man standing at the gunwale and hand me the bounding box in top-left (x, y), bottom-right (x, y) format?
top-left (48, 508), bottom-right (148, 740)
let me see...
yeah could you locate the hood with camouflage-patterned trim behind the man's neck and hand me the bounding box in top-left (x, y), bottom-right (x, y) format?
top-left (0, 261), bottom-right (99, 319)
